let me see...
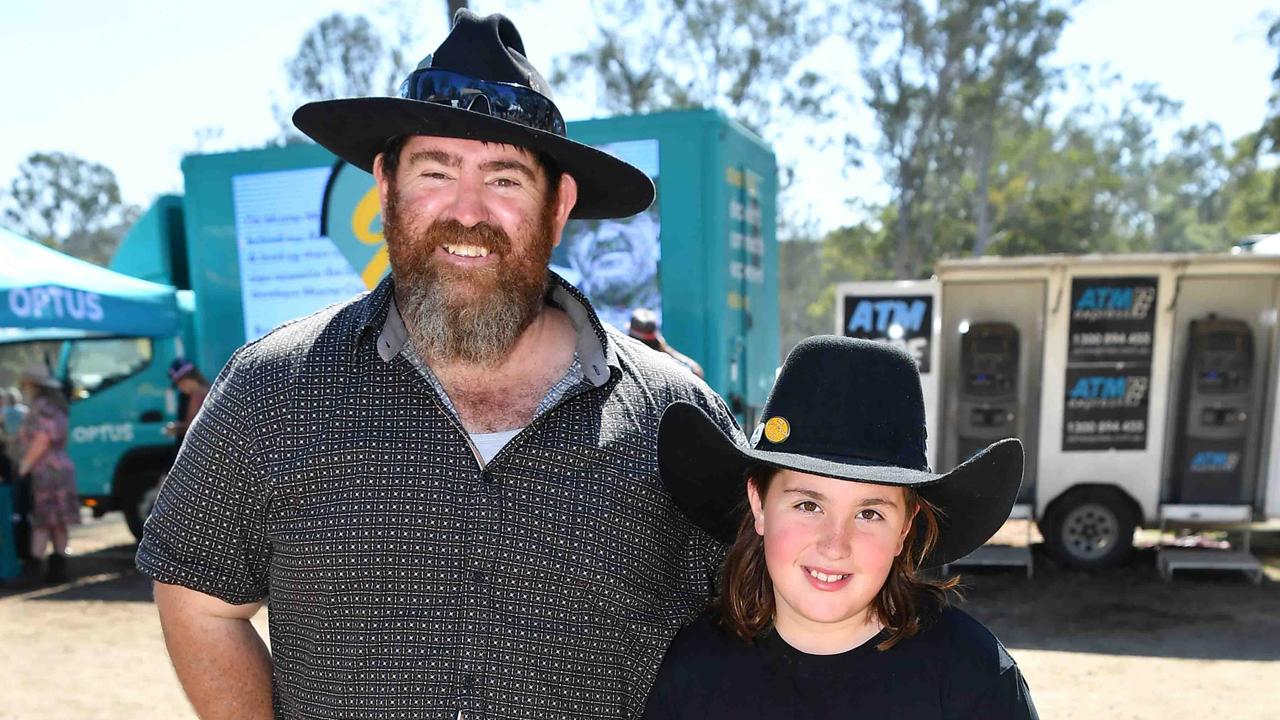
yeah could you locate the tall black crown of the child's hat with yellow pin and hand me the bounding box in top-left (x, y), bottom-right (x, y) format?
top-left (756, 336), bottom-right (928, 470)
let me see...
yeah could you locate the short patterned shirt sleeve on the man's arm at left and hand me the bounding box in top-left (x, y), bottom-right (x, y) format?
top-left (137, 352), bottom-right (271, 605)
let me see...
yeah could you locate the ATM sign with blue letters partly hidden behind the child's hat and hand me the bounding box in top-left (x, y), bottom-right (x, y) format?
top-left (841, 295), bottom-right (933, 375)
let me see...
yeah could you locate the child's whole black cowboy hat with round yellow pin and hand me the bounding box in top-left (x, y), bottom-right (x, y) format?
top-left (658, 336), bottom-right (1023, 568)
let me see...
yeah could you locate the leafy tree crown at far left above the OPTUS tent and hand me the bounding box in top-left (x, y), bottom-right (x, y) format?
top-left (4, 152), bottom-right (140, 265)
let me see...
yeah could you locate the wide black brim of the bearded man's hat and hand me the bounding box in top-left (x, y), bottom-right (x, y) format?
top-left (293, 97), bottom-right (654, 220)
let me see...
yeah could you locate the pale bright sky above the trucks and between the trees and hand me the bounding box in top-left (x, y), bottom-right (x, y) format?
top-left (0, 0), bottom-right (1276, 228)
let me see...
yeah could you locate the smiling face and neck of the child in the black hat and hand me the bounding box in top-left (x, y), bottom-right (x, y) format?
top-left (748, 470), bottom-right (910, 644)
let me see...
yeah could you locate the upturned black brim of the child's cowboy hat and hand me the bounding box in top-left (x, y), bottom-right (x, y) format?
top-left (658, 402), bottom-right (1023, 568)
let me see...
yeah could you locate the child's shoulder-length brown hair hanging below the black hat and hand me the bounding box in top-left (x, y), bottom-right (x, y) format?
top-left (718, 466), bottom-right (960, 651)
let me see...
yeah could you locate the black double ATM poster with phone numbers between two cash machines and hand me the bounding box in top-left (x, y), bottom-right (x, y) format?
top-left (1062, 277), bottom-right (1157, 451)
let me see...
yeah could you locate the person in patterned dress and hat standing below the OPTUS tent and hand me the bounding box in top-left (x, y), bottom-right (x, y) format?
top-left (18, 364), bottom-right (79, 583)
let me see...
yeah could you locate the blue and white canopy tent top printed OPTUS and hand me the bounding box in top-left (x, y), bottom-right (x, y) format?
top-left (0, 228), bottom-right (178, 343)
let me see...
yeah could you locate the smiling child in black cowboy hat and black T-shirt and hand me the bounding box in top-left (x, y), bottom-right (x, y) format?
top-left (644, 336), bottom-right (1037, 720)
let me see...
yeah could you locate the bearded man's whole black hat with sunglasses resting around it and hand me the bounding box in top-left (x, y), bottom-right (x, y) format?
top-left (293, 9), bottom-right (654, 218)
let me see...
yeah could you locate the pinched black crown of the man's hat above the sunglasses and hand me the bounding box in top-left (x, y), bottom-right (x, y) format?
top-left (428, 8), bottom-right (552, 97)
